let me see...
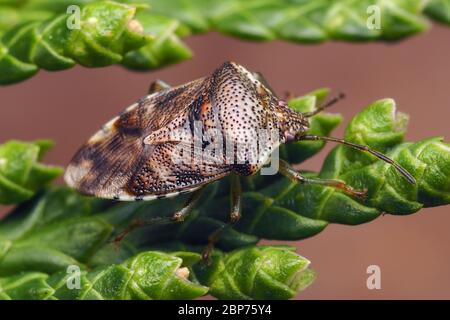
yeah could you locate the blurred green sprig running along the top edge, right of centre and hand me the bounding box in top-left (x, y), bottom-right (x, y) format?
top-left (133, 0), bottom-right (427, 43)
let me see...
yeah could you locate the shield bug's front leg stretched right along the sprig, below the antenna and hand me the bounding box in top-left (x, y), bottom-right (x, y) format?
top-left (279, 160), bottom-right (367, 199)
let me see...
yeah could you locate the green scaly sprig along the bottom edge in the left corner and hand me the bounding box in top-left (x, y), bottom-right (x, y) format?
top-left (0, 251), bottom-right (208, 300)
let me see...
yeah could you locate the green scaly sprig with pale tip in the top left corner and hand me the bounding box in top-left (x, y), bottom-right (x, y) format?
top-left (0, 1), bottom-right (153, 84)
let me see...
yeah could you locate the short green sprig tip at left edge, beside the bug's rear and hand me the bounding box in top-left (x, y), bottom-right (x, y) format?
top-left (0, 140), bottom-right (63, 204)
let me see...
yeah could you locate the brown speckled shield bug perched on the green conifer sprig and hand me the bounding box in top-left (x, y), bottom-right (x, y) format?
top-left (65, 62), bottom-right (415, 245)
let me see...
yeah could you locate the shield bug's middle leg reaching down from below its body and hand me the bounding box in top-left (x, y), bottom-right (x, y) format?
top-left (202, 174), bottom-right (242, 261)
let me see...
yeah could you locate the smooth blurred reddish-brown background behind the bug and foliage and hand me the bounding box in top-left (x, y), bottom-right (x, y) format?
top-left (0, 26), bottom-right (450, 299)
